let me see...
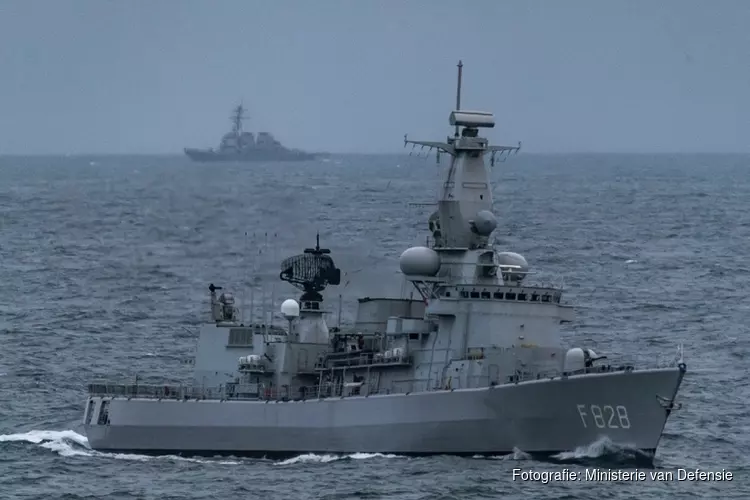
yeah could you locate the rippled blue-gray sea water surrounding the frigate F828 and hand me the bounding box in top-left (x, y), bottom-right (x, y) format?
top-left (0, 154), bottom-right (750, 500)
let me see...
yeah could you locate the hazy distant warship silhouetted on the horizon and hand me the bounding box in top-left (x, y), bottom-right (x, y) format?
top-left (185, 104), bottom-right (316, 162)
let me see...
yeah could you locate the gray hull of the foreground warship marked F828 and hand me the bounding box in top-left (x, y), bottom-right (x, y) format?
top-left (85, 366), bottom-right (684, 457)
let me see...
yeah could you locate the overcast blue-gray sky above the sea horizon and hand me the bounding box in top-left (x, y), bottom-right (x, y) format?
top-left (0, 0), bottom-right (750, 154)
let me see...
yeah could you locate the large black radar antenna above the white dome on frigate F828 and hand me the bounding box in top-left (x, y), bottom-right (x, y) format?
top-left (279, 233), bottom-right (341, 302)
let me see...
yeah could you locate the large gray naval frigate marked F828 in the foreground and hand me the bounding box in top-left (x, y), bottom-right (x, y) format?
top-left (83, 63), bottom-right (686, 457)
